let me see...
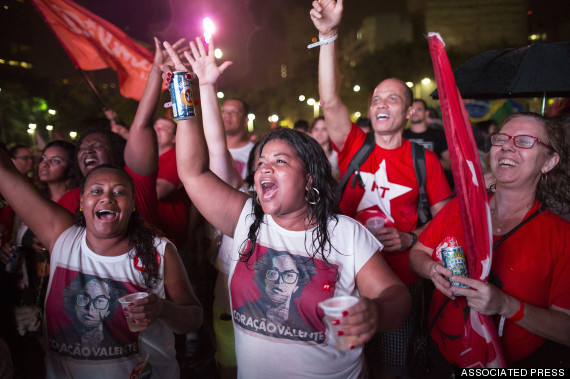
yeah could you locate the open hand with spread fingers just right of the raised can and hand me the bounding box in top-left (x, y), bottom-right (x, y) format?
top-left (184, 37), bottom-right (232, 86)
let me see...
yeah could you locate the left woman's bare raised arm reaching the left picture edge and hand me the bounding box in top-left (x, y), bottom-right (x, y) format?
top-left (0, 148), bottom-right (73, 251)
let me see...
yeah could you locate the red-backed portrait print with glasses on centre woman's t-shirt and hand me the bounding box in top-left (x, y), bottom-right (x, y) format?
top-left (232, 244), bottom-right (337, 343)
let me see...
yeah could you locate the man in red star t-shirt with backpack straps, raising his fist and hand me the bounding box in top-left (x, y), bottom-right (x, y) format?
top-left (311, 2), bottom-right (451, 376)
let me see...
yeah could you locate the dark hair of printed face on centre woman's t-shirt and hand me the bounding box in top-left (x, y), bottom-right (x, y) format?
top-left (253, 248), bottom-right (317, 297)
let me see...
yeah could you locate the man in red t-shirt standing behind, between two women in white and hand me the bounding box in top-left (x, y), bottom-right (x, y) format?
top-left (154, 118), bottom-right (190, 250)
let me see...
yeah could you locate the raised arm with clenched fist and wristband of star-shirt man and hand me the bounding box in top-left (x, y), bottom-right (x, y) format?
top-left (310, 0), bottom-right (351, 149)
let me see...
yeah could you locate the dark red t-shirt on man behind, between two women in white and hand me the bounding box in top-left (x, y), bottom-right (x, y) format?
top-left (158, 147), bottom-right (190, 247)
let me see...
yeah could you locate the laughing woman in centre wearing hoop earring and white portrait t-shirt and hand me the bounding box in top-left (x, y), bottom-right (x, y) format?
top-left (165, 39), bottom-right (410, 378)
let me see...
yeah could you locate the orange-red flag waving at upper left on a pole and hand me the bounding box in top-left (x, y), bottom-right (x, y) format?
top-left (31, 0), bottom-right (153, 100)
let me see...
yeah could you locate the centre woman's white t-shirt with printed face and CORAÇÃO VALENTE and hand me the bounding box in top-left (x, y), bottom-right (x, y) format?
top-left (229, 200), bottom-right (382, 379)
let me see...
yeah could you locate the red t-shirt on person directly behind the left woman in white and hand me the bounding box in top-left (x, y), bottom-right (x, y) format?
top-left (57, 166), bottom-right (157, 226)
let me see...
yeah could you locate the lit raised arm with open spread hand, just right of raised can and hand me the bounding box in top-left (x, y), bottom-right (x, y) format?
top-left (184, 37), bottom-right (242, 188)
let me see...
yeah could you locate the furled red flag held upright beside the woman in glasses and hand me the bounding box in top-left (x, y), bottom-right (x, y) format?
top-left (428, 33), bottom-right (506, 367)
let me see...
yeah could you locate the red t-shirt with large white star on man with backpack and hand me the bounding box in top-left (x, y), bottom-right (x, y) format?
top-left (335, 124), bottom-right (451, 284)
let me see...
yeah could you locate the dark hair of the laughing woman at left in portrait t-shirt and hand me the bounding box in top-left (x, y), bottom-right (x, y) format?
top-left (75, 164), bottom-right (161, 288)
